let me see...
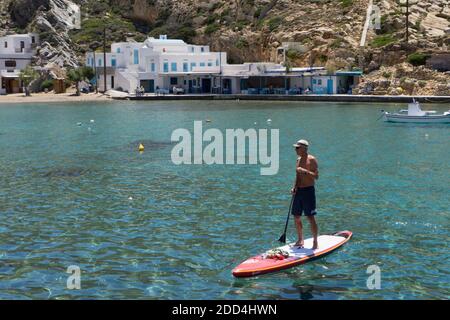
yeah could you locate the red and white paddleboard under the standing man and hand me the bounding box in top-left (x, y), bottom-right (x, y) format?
top-left (233, 231), bottom-right (352, 277)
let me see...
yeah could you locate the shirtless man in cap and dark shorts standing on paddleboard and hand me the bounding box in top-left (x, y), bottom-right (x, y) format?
top-left (291, 140), bottom-right (319, 250)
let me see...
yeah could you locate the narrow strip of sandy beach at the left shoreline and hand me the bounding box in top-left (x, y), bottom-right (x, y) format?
top-left (0, 92), bottom-right (111, 105)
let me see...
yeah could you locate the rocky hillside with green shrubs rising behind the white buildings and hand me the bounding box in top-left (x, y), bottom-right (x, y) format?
top-left (0, 0), bottom-right (450, 94)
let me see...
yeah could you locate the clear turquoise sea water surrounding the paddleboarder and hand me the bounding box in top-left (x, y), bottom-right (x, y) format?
top-left (0, 101), bottom-right (450, 299)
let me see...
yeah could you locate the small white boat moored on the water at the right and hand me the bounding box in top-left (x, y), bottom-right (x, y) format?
top-left (382, 99), bottom-right (450, 123)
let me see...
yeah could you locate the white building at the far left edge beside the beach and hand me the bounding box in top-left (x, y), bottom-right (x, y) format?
top-left (0, 33), bottom-right (39, 94)
